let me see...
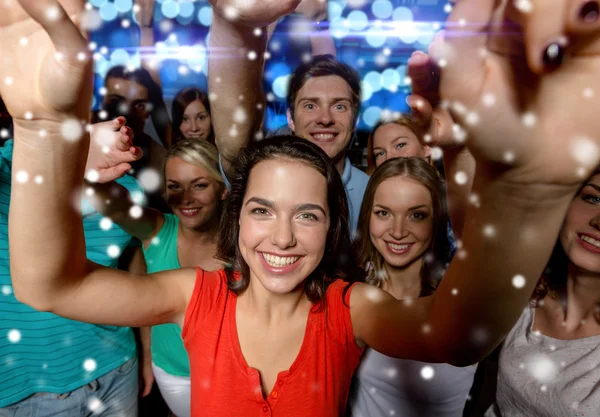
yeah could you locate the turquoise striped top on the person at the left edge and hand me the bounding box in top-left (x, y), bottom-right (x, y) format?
top-left (0, 140), bottom-right (141, 407)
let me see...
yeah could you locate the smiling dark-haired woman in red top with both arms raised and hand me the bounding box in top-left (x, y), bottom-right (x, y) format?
top-left (7, 0), bottom-right (600, 417)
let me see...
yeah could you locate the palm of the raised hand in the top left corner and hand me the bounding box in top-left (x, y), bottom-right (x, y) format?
top-left (0, 0), bottom-right (92, 125)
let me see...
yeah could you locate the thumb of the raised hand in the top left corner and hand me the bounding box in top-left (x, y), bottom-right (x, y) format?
top-left (19, 0), bottom-right (87, 53)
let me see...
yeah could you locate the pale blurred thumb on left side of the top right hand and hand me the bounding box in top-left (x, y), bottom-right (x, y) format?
top-left (440, 0), bottom-right (496, 105)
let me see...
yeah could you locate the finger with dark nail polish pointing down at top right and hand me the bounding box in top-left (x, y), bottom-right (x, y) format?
top-left (507, 0), bottom-right (568, 74)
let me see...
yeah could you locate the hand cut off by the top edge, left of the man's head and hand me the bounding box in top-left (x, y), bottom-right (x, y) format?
top-left (209, 0), bottom-right (301, 28)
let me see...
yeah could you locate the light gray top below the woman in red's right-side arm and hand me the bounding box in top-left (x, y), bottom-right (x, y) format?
top-left (348, 349), bottom-right (477, 417)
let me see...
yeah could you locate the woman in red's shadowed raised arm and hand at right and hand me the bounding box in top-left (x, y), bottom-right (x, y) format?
top-left (351, 0), bottom-right (600, 365)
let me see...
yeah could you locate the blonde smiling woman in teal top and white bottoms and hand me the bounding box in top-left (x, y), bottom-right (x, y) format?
top-left (90, 140), bottom-right (227, 417)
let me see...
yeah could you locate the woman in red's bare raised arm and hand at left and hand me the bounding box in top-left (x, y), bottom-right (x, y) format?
top-left (0, 0), bottom-right (195, 326)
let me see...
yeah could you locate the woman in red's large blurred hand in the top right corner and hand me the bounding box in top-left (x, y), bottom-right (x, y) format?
top-left (431, 0), bottom-right (600, 186)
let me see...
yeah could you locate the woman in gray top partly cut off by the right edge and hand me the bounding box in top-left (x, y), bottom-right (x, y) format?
top-left (485, 171), bottom-right (600, 417)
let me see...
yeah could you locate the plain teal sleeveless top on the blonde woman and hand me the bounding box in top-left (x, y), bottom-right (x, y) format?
top-left (144, 214), bottom-right (190, 377)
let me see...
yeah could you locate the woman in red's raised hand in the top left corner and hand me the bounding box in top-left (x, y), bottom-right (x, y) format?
top-left (0, 0), bottom-right (93, 133)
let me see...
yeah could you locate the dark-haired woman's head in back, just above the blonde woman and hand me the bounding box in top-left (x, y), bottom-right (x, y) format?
top-left (171, 87), bottom-right (215, 144)
